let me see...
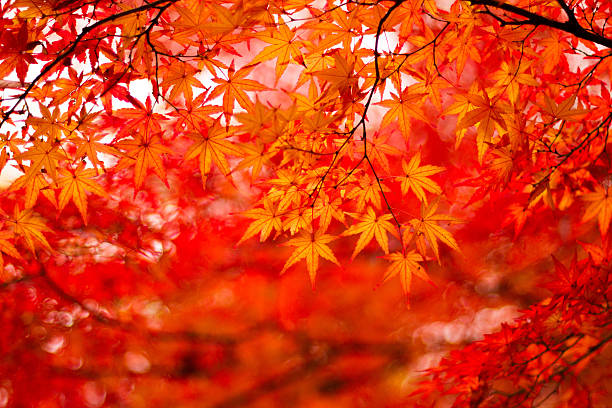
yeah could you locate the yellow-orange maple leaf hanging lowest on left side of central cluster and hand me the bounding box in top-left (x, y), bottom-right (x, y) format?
top-left (280, 231), bottom-right (340, 287)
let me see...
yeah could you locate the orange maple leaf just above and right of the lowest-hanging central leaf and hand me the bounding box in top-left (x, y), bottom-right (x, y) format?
top-left (406, 198), bottom-right (461, 263)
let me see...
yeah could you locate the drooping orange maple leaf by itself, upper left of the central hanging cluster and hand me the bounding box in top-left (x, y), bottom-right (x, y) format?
top-left (185, 122), bottom-right (243, 186)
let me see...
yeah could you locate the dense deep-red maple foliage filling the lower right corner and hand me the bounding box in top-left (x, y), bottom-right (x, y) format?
top-left (419, 244), bottom-right (612, 407)
